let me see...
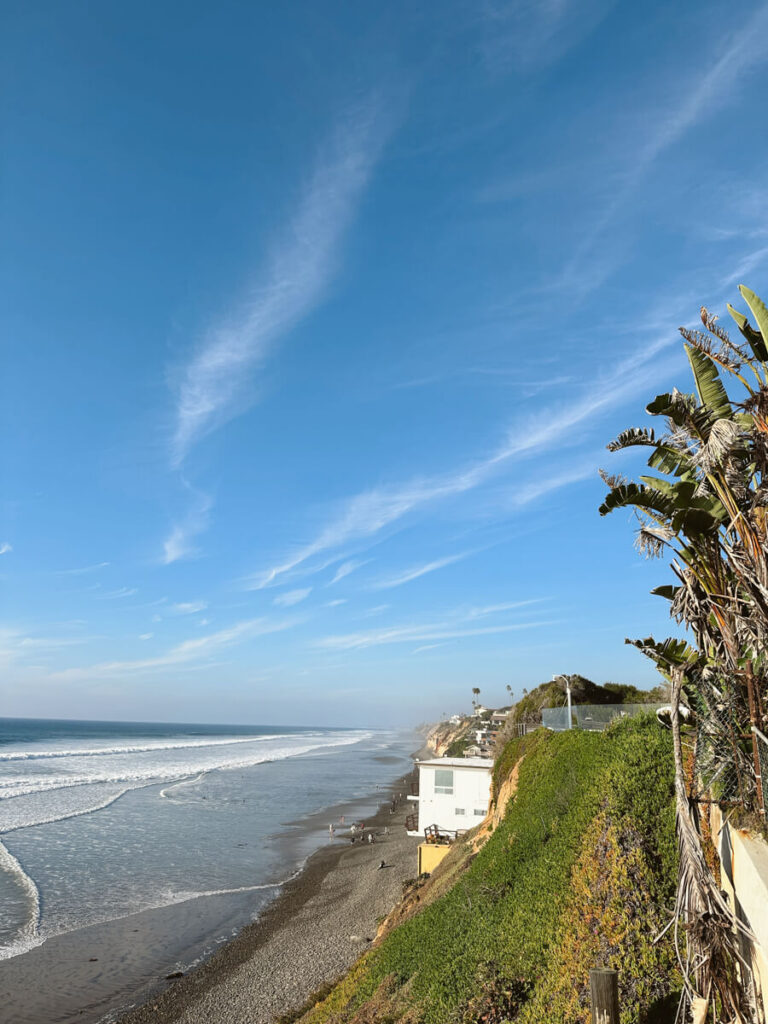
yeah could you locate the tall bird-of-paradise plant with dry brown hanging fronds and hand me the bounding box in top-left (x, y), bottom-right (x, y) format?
top-left (600, 286), bottom-right (768, 1021)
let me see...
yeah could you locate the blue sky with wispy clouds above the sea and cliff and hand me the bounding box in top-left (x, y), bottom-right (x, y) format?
top-left (0, 0), bottom-right (768, 725)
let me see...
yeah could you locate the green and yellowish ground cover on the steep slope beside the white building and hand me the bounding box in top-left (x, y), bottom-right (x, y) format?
top-left (292, 716), bottom-right (680, 1024)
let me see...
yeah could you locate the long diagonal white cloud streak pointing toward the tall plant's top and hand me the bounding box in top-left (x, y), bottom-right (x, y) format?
top-left (250, 332), bottom-right (674, 590)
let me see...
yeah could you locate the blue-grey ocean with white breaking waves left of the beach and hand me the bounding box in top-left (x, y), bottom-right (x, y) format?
top-left (0, 719), bottom-right (417, 1019)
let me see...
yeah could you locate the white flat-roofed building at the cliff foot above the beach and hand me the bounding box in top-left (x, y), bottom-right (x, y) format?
top-left (409, 758), bottom-right (494, 836)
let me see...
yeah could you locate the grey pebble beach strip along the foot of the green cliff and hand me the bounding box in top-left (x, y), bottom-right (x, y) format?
top-left (119, 770), bottom-right (418, 1024)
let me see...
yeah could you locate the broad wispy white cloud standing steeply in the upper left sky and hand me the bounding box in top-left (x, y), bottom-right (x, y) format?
top-left (172, 98), bottom-right (387, 465)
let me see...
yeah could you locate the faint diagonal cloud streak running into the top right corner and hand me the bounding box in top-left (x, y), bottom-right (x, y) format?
top-left (562, 11), bottom-right (768, 293)
